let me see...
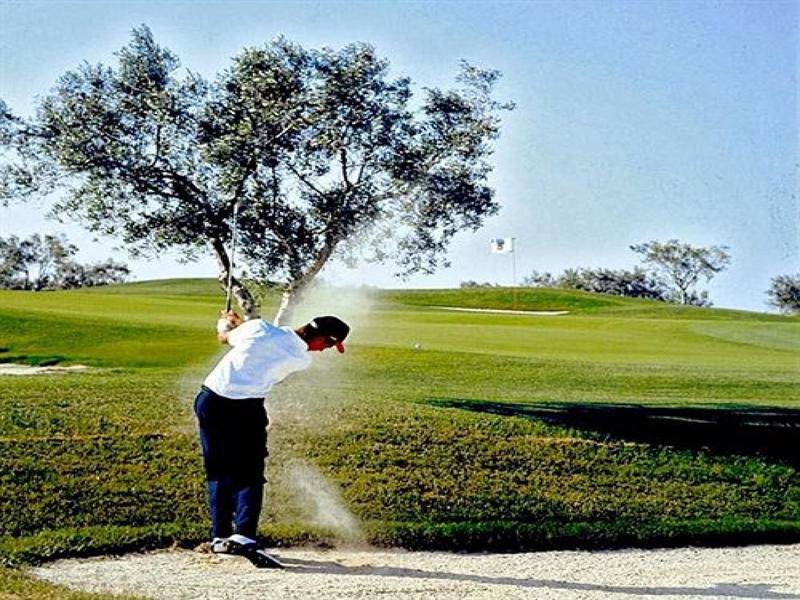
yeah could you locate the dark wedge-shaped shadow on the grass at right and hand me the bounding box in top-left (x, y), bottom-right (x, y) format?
top-left (427, 398), bottom-right (800, 468)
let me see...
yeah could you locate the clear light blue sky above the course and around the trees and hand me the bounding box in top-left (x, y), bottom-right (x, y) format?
top-left (0, 0), bottom-right (800, 310)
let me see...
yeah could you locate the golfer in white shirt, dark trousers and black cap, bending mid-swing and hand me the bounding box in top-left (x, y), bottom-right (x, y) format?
top-left (194, 311), bottom-right (350, 568)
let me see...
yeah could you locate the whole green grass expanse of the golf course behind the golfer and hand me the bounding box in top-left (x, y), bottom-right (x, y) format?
top-left (0, 280), bottom-right (800, 597)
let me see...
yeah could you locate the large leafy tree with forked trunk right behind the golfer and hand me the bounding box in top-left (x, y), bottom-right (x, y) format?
top-left (0, 26), bottom-right (511, 322)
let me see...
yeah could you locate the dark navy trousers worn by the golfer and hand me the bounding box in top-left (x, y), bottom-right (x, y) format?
top-left (194, 386), bottom-right (268, 539)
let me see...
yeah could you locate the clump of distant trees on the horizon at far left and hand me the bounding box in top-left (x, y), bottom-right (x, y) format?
top-left (0, 234), bottom-right (130, 291)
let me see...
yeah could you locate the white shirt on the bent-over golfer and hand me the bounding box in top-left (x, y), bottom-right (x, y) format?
top-left (203, 319), bottom-right (311, 399)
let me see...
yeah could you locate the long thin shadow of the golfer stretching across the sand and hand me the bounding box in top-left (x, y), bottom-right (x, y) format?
top-left (283, 558), bottom-right (798, 600)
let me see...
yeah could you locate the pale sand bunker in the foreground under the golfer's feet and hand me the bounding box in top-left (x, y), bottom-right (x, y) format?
top-left (32, 544), bottom-right (800, 600)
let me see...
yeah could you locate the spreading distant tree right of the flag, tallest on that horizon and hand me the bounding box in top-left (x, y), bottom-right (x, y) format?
top-left (631, 240), bottom-right (731, 306)
